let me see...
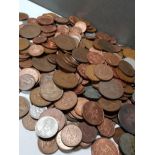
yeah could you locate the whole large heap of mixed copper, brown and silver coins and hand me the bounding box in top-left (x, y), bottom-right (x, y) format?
top-left (19, 12), bottom-right (135, 155)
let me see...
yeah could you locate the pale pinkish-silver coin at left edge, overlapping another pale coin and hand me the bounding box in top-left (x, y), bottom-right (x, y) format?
top-left (19, 74), bottom-right (35, 90)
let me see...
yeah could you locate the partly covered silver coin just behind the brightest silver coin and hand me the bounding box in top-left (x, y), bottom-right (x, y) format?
top-left (30, 105), bottom-right (47, 119)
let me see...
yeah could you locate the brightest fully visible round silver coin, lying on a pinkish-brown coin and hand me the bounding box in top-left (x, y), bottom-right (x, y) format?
top-left (35, 116), bottom-right (58, 138)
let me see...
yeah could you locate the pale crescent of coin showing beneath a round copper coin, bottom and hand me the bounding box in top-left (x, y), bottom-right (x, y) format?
top-left (56, 131), bottom-right (74, 151)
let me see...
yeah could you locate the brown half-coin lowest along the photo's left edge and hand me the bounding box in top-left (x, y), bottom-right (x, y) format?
top-left (19, 96), bottom-right (30, 118)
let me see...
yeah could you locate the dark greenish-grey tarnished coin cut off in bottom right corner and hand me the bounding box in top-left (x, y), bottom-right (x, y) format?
top-left (119, 133), bottom-right (135, 155)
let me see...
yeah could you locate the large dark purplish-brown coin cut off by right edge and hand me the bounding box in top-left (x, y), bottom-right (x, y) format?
top-left (118, 104), bottom-right (135, 134)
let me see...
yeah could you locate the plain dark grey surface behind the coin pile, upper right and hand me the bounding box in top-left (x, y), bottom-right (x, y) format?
top-left (30, 0), bottom-right (135, 48)
